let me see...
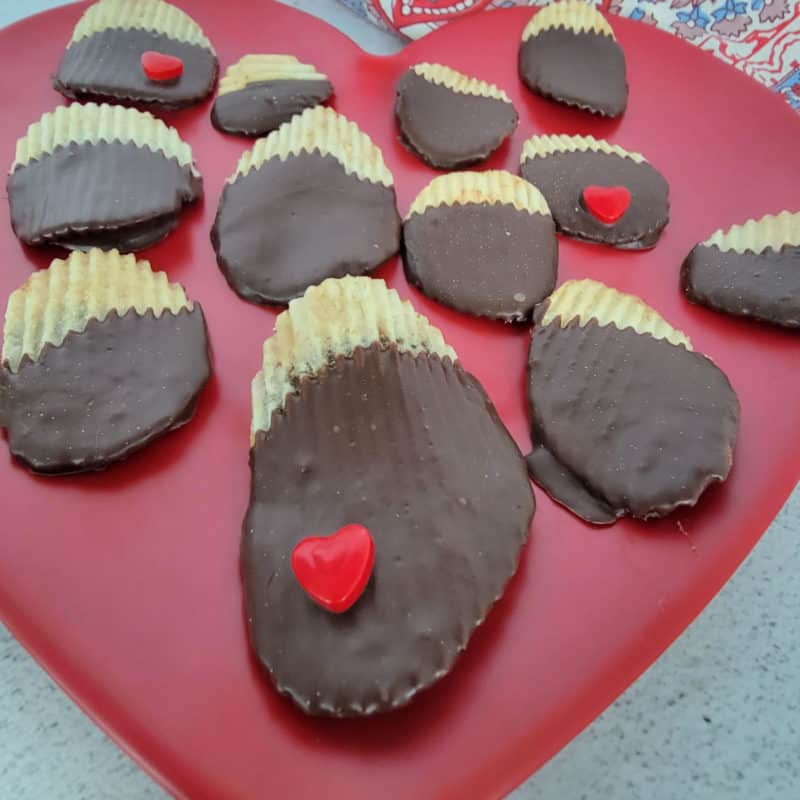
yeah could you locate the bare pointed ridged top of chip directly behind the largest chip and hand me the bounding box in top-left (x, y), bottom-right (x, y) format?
top-left (228, 106), bottom-right (394, 186)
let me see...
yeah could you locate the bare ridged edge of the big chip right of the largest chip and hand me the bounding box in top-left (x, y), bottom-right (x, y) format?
top-left (539, 278), bottom-right (692, 350)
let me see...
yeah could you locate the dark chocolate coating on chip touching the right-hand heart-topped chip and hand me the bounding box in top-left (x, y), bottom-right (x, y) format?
top-left (403, 203), bottom-right (558, 322)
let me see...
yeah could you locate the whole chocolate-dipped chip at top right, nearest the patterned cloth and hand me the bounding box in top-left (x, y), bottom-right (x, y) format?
top-left (519, 0), bottom-right (628, 117)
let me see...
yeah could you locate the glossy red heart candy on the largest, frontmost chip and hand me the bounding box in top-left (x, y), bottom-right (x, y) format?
top-left (292, 524), bottom-right (375, 614)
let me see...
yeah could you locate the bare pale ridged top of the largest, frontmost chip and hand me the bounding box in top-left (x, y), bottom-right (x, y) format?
top-left (251, 276), bottom-right (457, 443)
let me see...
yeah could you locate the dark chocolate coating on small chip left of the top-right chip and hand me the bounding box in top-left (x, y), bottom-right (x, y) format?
top-left (395, 69), bottom-right (519, 169)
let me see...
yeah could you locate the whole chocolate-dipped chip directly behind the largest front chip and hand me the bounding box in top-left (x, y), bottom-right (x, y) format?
top-left (211, 106), bottom-right (401, 305)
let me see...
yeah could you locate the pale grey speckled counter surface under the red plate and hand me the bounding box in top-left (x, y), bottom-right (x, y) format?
top-left (0, 0), bottom-right (800, 800)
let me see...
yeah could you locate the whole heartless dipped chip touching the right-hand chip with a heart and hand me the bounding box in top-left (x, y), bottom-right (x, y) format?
top-left (403, 170), bottom-right (558, 322)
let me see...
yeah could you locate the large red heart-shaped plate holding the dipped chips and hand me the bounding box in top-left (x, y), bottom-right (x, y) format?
top-left (0, 0), bottom-right (800, 800)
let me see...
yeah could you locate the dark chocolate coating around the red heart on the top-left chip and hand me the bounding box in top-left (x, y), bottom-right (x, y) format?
top-left (53, 28), bottom-right (218, 109)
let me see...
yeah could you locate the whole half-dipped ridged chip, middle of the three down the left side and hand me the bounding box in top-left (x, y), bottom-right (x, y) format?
top-left (7, 103), bottom-right (203, 252)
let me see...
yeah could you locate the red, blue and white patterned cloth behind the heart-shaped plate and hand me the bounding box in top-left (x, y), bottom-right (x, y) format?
top-left (341, 0), bottom-right (800, 111)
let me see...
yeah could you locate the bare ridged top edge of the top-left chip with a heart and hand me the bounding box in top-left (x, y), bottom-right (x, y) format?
top-left (70, 0), bottom-right (214, 53)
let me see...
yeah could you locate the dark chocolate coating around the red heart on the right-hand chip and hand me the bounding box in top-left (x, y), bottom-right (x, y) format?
top-left (520, 150), bottom-right (669, 249)
